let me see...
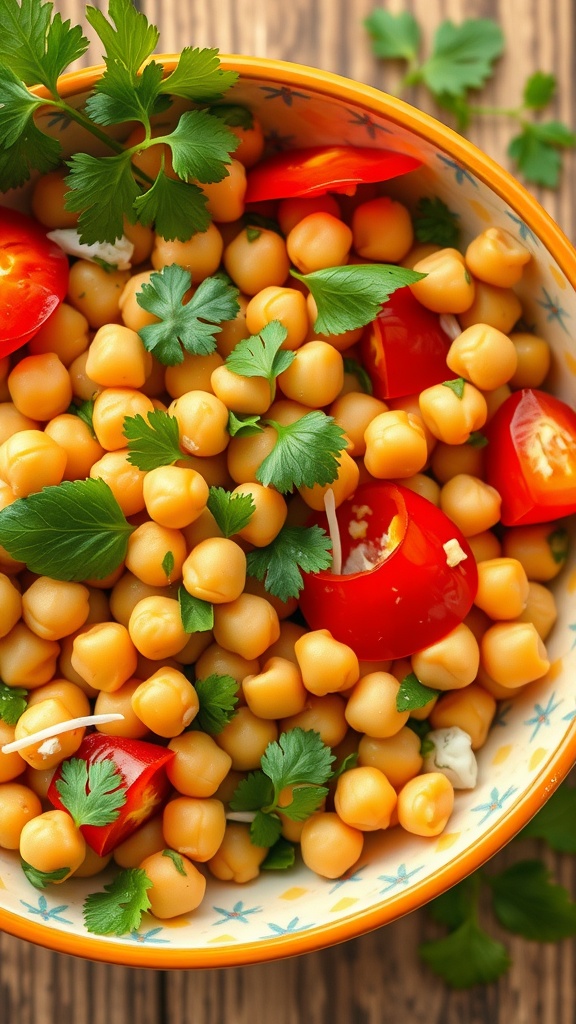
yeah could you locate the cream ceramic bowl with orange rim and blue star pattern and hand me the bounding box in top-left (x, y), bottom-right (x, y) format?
top-left (0, 55), bottom-right (576, 969)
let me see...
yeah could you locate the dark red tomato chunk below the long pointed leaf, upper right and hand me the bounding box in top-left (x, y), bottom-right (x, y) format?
top-left (361, 288), bottom-right (454, 399)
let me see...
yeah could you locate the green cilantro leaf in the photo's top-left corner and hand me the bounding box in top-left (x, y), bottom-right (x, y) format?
top-left (0, 0), bottom-right (89, 95)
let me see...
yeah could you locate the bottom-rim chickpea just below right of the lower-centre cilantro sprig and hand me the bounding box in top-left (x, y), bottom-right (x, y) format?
top-left (300, 811), bottom-right (364, 879)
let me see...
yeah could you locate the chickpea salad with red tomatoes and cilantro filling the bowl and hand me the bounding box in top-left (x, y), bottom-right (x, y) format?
top-left (0, 0), bottom-right (576, 935)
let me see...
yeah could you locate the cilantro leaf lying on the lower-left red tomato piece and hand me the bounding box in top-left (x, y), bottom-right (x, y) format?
top-left (56, 758), bottom-right (126, 828)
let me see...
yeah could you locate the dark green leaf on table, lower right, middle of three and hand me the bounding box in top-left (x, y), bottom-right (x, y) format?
top-left (487, 860), bottom-right (576, 942)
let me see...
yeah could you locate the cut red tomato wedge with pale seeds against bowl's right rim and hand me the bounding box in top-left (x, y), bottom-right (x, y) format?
top-left (485, 388), bottom-right (576, 526)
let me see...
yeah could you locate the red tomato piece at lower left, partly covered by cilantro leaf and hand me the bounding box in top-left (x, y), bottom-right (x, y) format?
top-left (47, 732), bottom-right (174, 857)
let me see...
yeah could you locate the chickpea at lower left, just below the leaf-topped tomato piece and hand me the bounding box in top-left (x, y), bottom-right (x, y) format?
top-left (19, 811), bottom-right (86, 885)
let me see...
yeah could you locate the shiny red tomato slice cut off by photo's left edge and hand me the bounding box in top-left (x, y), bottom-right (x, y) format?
top-left (0, 207), bottom-right (69, 356)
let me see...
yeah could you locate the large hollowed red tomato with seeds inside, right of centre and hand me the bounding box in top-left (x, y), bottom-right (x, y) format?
top-left (300, 481), bottom-right (478, 662)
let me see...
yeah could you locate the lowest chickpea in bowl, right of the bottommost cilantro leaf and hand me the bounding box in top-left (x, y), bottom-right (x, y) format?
top-left (138, 850), bottom-right (206, 921)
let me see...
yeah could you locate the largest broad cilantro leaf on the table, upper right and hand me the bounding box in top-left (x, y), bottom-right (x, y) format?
top-left (419, 17), bottom-right (504, 96)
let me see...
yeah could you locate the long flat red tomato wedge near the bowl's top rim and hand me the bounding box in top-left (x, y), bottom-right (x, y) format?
top-left (241, 145), bottom-right (421, 203)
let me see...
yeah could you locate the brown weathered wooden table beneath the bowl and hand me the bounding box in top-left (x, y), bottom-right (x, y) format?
top-left (0, 0), bottom-right (576, 1024)
